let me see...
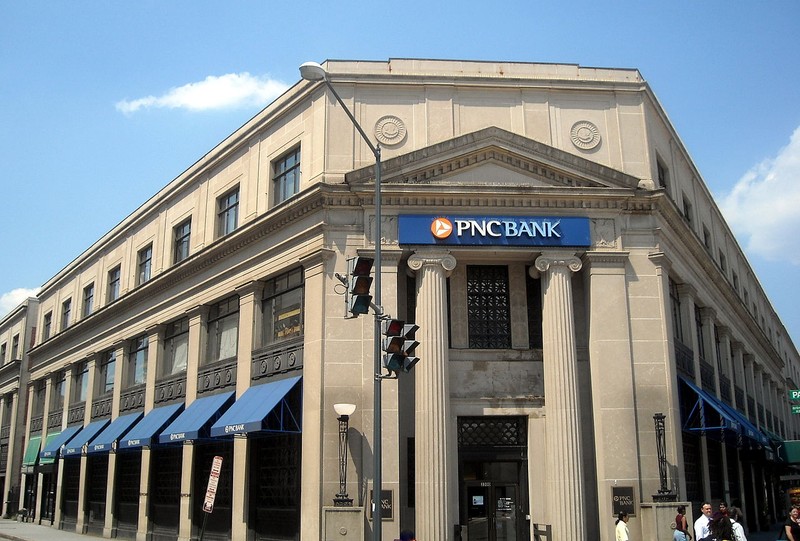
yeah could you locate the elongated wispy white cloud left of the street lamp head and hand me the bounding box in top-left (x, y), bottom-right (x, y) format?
top-left (116, 72), bottom-right (289, 114)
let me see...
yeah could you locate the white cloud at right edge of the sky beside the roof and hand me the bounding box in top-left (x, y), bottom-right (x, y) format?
top-left (721, 127), bottom-right (800, 266)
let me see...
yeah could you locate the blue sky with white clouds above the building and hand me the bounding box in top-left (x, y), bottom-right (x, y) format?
top-left (0, 0), bottom-right (800, 343)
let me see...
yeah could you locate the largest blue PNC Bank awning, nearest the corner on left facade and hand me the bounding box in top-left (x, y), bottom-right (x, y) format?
top-left (211, 376), bottom-right (301, 437)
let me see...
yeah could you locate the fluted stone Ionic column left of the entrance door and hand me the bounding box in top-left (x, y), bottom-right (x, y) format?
top-left (408, 250), bottom-right (457, 541)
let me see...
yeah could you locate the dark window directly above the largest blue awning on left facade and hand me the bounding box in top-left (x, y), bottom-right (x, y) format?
top-left (261, 269), bottom-right (303, 346)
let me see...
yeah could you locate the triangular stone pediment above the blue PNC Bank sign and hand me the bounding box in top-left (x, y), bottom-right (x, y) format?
top-left (346, 127), bottom-right (639, 189)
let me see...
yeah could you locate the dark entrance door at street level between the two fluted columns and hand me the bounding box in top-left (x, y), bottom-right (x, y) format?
top-left (465, 481), bottom-right (519, 541)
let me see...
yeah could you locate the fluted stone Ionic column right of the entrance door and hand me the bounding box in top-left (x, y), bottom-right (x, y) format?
top-left (536, 252), bottom-right (586, 541)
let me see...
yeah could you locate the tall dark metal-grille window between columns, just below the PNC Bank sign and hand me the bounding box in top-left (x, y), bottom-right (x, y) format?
top-left (467, 265), bottom-right (511, 349)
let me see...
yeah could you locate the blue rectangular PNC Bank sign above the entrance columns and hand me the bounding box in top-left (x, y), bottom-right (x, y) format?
top-left (398, 214), bottom-right (591, 247)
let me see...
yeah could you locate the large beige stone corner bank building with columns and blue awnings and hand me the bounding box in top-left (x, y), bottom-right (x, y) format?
top-left (0, 59), bottom-right (800, 541)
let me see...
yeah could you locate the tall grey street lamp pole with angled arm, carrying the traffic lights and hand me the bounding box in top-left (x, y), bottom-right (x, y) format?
top-left (300, 62), bottom-right (383, 541)
